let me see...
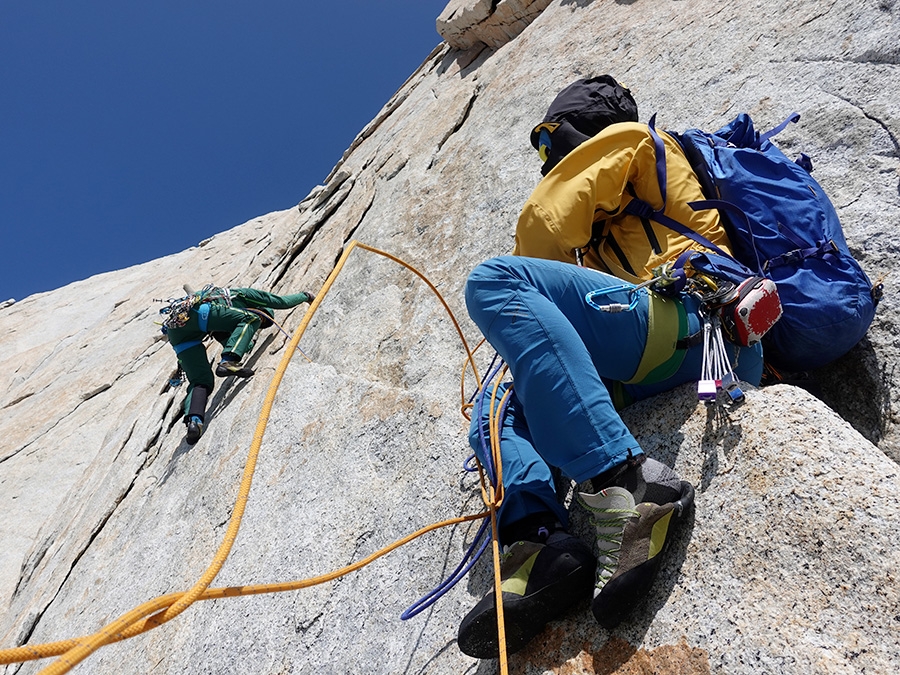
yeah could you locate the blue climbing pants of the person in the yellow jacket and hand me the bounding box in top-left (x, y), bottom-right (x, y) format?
top-left (466, 256), bottom-right (762, 527)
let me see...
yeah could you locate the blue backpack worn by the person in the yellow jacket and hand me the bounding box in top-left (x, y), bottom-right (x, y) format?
top-left (673, 113), bottom-right (881, 372)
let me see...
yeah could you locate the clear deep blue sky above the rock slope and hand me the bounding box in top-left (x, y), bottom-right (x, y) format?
top-left (0, 0), bottom-right (447, 302)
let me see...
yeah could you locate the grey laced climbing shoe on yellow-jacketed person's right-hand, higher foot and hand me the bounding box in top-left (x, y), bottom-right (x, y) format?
top-left (578, 455), bottom-right (694, 629)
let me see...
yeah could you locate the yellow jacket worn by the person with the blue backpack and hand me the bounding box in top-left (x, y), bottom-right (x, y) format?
top-left (513, 122), bottom-right (731, 283)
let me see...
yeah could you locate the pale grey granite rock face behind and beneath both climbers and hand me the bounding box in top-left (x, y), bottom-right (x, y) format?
top-left (0, 0), bottom-right (900, 675)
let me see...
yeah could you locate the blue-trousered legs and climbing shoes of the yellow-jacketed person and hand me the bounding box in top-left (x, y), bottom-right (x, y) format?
top-left (458, 256), bottom-right (762, 658)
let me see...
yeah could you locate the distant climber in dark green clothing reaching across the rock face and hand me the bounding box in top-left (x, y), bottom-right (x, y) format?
top-left (163, 286), bottom-right (313, 445)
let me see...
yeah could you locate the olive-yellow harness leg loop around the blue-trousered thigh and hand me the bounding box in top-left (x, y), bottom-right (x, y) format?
top-left (625, 291), bottom-right (687, 384)
